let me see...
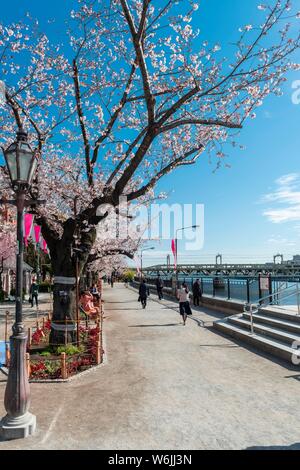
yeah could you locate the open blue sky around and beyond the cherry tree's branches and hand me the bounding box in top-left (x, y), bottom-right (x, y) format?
top-left (1, 0), bottom-right (300, 264)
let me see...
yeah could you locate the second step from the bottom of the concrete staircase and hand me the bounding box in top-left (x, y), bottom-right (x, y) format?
top-left (228, 315), bottom-right (300, 346)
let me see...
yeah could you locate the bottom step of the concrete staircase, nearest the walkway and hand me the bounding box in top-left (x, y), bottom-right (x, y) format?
top-left (214, 319), bottom-right (300, 367)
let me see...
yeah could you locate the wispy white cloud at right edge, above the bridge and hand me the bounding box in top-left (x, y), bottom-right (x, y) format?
top-left (262, 173), bottom-right (300, 224)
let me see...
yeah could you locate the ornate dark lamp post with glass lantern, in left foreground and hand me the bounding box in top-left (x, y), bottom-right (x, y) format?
top-left (0, 129), bottom-right (39, 439)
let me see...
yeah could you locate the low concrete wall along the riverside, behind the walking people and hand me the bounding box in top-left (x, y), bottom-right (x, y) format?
top-left (131, 281), bottom-right (244, 316)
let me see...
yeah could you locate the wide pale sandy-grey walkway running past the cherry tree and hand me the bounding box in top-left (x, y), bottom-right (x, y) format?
top-left (0, 285), bottom-right (300, 450)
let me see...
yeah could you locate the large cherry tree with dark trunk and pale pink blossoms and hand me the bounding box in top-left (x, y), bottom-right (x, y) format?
top-left (0, 0), bottom-right (300, 343)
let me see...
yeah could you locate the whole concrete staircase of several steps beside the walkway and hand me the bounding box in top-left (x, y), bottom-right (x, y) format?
top-left (214, 306), bottom-right (300, 367)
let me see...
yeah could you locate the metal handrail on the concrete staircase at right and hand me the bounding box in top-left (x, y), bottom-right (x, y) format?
top-left (244, 283), bottom-right (300, 335)
